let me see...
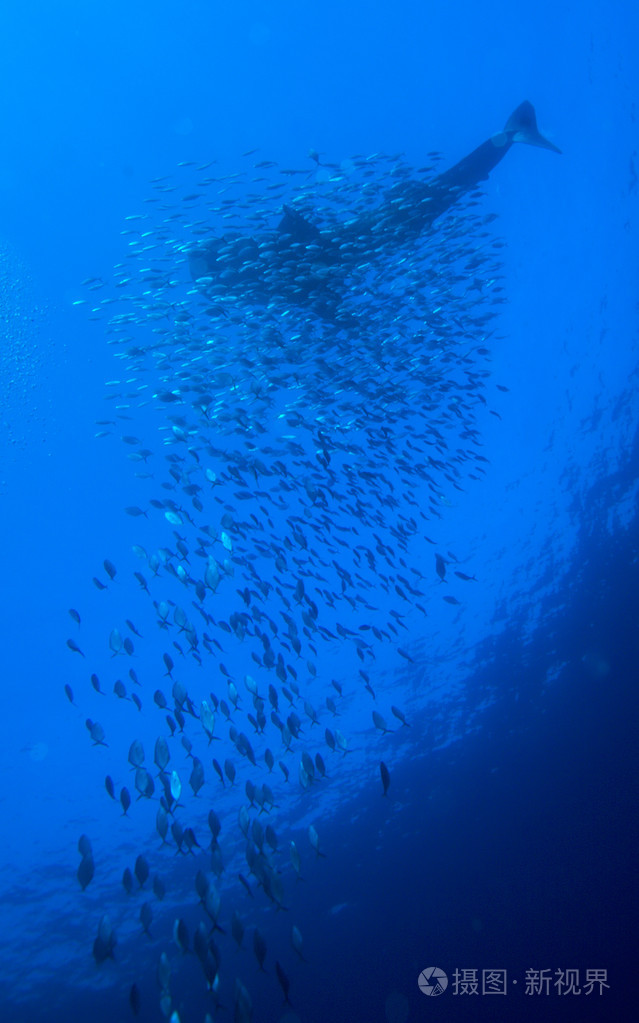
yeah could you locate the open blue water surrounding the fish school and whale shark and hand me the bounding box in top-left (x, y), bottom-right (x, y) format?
top-left (0, 0), bottom-right (639, 1023)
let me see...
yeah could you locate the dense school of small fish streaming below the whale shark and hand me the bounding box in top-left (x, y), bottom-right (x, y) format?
top-left (65, 153), bottom-right (503, 1023)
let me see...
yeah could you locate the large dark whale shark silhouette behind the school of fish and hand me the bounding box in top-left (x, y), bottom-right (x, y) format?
top-left (188, 100), bottom-right (561, 325)
